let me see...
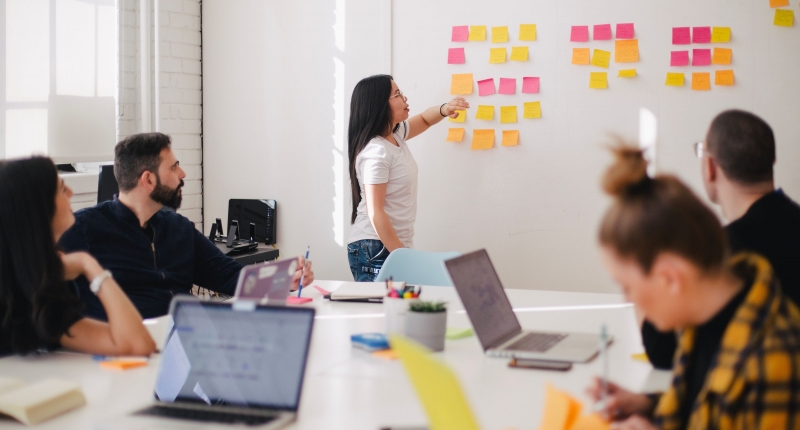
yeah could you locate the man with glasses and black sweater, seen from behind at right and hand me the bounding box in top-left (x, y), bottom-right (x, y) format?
top-left (642, 110), bottom-right (800, 369)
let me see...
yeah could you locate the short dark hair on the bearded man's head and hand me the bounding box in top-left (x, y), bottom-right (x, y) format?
top-left (114, 133), bottom-right (172, 191)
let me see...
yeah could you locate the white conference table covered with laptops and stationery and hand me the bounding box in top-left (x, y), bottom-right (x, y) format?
top-left (0, 281), bottom-right (670, 430)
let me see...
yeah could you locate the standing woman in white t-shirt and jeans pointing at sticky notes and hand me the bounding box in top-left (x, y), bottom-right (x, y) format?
top-left (347, 75), bottom-right (469, 282)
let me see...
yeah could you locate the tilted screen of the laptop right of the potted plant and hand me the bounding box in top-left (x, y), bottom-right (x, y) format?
top-left (444, 249), bottom-right (522, 350)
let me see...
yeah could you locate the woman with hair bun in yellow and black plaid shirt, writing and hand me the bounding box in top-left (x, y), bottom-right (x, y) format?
top-left (588, 146), bottom-right (800, 429)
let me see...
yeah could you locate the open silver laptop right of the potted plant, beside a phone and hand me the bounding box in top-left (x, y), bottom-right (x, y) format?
top-left (444, 249), bottom-right (600, 363)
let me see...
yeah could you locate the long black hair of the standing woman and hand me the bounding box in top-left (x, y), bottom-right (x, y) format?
top-left (347, 75), bottom-right (400, 224)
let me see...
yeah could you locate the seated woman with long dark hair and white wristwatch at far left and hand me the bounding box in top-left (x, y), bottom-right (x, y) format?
top-left (0, 157), bottom-right (155, 356)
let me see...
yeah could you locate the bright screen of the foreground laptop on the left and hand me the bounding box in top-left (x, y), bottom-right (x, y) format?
top-left (155, 300), bottom-right (314, 411)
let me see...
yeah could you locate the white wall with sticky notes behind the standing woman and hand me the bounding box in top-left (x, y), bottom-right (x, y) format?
top-left (203, 0), bottom-right (800, 291)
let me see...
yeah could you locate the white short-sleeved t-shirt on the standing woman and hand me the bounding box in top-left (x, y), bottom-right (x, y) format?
top-left (347, 121), bottom-right (418, 248)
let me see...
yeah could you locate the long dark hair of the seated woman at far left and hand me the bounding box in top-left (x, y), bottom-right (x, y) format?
top-left (0, 157), bottom-right (81, 354)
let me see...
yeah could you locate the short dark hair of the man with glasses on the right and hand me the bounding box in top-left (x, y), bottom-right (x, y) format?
top-left (706, 110), bottom-right (775, 185)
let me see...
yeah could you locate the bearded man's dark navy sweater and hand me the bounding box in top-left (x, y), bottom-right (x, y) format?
top-left (58, 197), bottom-right (242, 320)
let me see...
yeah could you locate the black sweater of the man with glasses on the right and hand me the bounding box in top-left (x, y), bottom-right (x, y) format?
top-left (642, 190), bottom-right (800, 369)
